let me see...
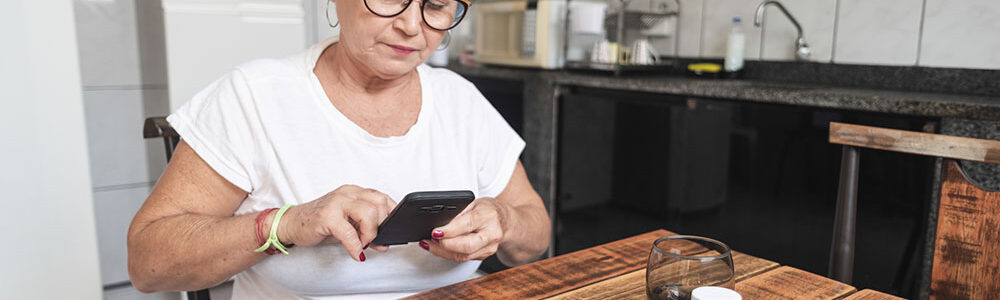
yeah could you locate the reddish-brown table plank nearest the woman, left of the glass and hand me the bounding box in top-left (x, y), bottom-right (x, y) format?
top-left (405, 229), bottom-right (676, 300)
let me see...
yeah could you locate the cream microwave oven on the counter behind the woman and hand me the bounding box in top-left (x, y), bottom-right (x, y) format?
top-left (474, 0), bottom-right (566, 69)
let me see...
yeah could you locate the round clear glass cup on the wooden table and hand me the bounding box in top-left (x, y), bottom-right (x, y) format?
top-left (646, 235), bottom-right (736, 300)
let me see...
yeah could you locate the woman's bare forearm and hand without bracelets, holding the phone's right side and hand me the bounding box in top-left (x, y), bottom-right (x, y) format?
top-left (420, 161), bottom-right (552, 266)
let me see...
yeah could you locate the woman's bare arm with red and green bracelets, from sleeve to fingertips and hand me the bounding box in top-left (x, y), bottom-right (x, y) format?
top-left (128, 141), bottom-right (396, 292)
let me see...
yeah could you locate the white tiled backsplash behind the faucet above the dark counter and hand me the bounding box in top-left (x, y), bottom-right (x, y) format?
top-left (608, 0), bottom-right (1000, 69)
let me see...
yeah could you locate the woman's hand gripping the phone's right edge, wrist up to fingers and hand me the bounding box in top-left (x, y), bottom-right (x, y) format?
top-left (420, 198), bottom-right (509, 262)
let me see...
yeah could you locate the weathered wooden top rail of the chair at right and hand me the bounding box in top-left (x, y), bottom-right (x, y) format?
top-left (830, 122), bottom-right (1000, 164)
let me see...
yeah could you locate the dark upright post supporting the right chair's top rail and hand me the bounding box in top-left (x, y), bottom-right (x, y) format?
top-left (828, 145), bottom-right (860, 284)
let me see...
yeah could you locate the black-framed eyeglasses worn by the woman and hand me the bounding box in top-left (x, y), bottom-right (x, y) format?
top-left (365, 0), bottom-right (470, 31)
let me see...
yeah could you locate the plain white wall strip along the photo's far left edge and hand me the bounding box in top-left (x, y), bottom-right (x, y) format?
top-left (0, 0), bottom-right (101, 299)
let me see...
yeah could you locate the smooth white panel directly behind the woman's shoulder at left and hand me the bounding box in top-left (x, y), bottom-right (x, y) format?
top-left (162, 0), bottom-right (312, 110)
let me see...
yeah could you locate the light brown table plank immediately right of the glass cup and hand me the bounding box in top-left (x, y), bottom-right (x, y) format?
top-left (736, 266), bottom-right (855, 300)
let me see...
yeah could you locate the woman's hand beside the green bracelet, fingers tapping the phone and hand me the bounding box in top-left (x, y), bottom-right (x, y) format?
top-left (278, 185), bottom-right (396, 261)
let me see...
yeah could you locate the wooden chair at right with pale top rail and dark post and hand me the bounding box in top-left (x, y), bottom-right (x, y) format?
top-left (829, 122), bottom-right (1000, 299)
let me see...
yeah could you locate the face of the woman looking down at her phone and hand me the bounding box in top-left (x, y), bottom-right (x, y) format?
top-left (335, 0), bottom-right (445, 79)
